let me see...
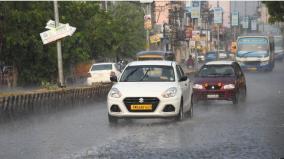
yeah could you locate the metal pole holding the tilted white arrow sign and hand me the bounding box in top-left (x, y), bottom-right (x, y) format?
top-left (53, 0), bottom-right (65, 87)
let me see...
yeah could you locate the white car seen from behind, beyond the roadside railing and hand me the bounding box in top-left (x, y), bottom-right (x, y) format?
top-left (87, 63), bottom-right (121, 85)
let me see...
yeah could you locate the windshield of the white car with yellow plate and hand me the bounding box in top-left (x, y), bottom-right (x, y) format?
top-left (120, 66), bottom-right (175, 82)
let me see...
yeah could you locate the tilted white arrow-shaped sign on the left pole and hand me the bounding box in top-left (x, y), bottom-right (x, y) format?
top-left (40, 23), bottom-right (76, 44)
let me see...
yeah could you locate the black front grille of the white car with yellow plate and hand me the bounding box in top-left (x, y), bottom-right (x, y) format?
top-left (123, 97), bottom-right (160, 112)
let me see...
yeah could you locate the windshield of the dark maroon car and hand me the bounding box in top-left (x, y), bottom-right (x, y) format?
top-left (198, 65), bottom-right (235, 77)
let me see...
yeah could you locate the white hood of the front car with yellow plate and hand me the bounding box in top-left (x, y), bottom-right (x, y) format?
top-left (113, 82), bottom-right (177, 97)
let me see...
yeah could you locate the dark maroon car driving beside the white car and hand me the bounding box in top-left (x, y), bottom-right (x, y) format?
top-left (193, 61), bottom-right (246, 104)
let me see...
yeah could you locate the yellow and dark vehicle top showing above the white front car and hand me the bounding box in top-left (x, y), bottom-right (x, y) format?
top-left (136, 51), bottom-right (175, 61)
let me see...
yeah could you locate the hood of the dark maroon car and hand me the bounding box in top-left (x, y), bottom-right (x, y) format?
top-left (194, 76), bottom-right (236, 84)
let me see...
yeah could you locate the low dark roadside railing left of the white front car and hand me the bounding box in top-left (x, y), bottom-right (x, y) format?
top-left (0, 84), bottom-right (112, 116)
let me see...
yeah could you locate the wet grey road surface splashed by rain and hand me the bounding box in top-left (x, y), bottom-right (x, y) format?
top-left (0, 62), bottom-right (284, 159)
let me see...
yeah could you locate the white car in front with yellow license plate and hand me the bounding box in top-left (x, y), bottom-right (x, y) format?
top-left (107, 61), bottom-right (193, 123)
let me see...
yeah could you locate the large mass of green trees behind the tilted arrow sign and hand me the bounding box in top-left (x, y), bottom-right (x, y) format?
top-left (0, 1), bottom-right (144, 84)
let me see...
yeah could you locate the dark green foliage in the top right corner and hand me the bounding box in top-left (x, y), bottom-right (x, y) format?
top-left (262, 1), bottom-right (284, 23)
